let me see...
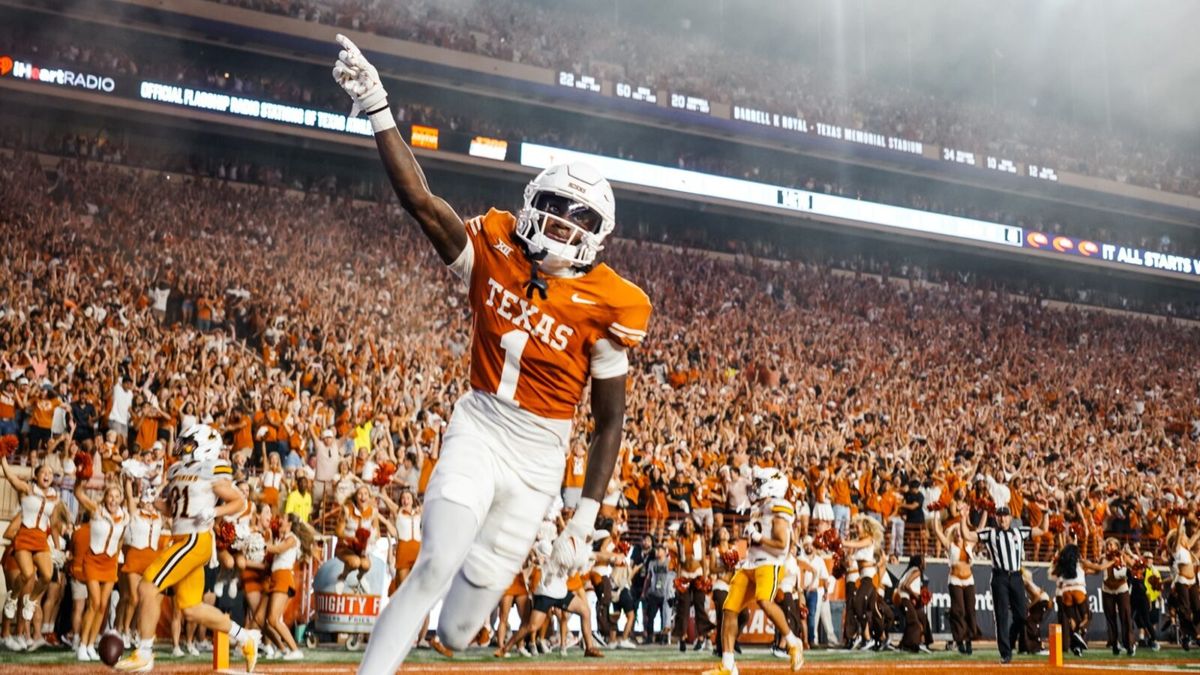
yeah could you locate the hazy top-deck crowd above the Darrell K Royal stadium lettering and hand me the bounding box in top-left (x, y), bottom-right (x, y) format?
top-left (199, 0), bottom-right (1200, 193)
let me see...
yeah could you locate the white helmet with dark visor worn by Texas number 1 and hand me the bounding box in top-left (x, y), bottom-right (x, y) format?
top-left (516, 162), bottom-right (617, 269)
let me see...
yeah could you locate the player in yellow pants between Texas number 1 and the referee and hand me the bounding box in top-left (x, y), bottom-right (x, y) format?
top-left (704, 468), bottom-right (804, 675)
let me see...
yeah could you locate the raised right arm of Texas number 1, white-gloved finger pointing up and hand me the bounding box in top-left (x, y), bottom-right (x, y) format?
top-left (334, 35), bottom-right (468, 264)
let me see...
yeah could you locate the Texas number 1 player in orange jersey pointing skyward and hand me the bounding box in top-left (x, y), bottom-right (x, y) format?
top-left (334, 36), bottom-right (650, 675)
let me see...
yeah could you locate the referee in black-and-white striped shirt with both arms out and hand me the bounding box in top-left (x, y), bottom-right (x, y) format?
top-left (964, 506), bottom-right (1043, 664)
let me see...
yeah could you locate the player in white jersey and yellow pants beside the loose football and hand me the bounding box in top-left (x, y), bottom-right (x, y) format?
top-left (116, 424), bottom-right (260, 673)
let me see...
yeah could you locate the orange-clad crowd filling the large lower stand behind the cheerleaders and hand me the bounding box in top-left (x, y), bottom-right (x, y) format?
top-left (0, 133), bottom-right (1200, 653)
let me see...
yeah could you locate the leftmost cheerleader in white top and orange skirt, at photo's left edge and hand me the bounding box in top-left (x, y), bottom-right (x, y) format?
top-left (0, 458), bottom-right (68, 625)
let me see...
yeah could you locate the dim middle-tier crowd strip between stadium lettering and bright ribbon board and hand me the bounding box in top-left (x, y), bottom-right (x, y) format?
top-left (5, 28), bottom-right (1200, 257)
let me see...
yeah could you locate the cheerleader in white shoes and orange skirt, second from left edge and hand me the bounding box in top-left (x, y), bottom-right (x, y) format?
top-left (74, 480), bottom-right (128, 661)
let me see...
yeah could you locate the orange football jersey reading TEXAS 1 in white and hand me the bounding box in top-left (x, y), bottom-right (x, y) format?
top-left (466, 209), bottom-right (650, 419)
